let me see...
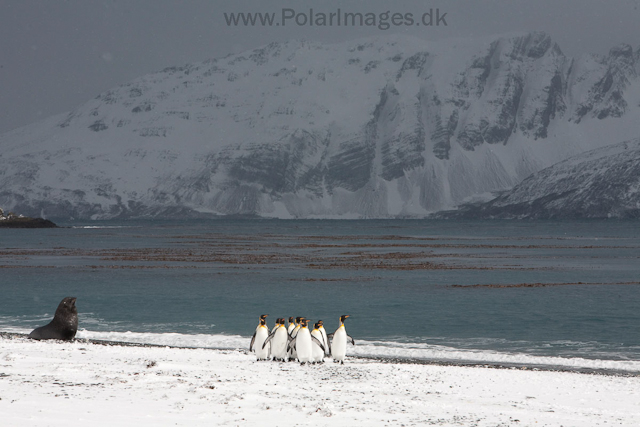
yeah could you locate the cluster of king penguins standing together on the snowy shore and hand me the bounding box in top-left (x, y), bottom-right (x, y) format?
top-left (249, 314), bottom-right (356, 365)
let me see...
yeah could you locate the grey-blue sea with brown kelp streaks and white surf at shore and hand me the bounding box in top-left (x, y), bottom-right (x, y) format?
top-left (0, 218), bottom-right (640, 373)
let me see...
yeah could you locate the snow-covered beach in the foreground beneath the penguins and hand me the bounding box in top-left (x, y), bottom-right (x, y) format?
top-left (0, 334), bottom-right (640, 427)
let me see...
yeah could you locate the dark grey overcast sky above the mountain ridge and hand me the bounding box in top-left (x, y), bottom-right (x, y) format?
top-left (0, 0), bottom-right (640, 133)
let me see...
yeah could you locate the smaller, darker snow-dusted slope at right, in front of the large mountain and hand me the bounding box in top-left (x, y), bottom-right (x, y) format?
top-left (446, 139), bottom-right (640, 219)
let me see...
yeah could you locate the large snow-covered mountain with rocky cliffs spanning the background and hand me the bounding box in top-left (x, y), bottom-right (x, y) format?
top-left (0, 33), bottom-right (640, 218)
